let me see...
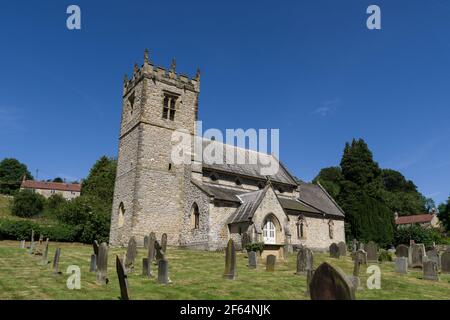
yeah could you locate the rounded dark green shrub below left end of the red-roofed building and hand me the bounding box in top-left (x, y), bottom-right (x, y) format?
top-left (11, 190), bottom-right (45, 217)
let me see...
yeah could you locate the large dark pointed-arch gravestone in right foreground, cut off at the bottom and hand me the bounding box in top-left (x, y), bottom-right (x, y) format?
top-left (310, 262), bottom-right (355, 300)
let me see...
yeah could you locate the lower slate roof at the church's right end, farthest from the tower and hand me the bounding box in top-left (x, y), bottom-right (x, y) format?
top-left (299, 182), bottom-right (344, 217)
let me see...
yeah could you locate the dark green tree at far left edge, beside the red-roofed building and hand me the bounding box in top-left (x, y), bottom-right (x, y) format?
top-left (0, 158), bottom-right (33, 194)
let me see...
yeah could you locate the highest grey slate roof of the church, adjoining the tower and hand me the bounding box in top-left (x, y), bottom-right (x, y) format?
top-left (202, 139), bottom-right (297, 186)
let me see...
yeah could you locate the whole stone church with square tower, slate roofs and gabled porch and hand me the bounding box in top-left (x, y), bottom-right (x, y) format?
top-left (110, 51), bottom-right (345, 258)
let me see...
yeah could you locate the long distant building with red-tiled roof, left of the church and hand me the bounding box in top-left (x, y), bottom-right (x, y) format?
top-left (20, 180), bottom-right (81, 200)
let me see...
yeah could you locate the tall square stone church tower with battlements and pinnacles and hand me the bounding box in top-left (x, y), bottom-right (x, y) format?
top-left (110, 50), bottom-right (200, 246)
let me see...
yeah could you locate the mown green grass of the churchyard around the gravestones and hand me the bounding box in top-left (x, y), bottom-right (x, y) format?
top-left (0, 241), bottom-right (450, 300)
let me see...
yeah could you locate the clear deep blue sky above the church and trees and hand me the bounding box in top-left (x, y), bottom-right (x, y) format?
top-left (0, 0), bottom-right (450, 202)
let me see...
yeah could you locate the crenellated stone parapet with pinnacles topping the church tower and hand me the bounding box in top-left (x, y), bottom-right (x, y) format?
top-left (123, 49), bottom-right (200, 96)
